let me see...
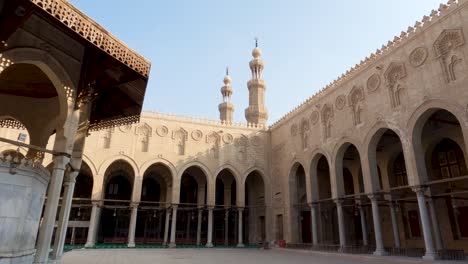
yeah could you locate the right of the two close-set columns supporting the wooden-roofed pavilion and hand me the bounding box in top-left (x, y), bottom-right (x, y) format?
top-left (52, 171), bottom-right (78, 262)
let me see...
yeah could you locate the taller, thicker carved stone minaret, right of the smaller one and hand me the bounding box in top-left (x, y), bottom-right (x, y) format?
top-left (245, 39), bottom-right (268, 126)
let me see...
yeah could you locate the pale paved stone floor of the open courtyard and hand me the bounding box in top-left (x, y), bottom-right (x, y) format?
top-left (62, 249), bottom-right (460, 264)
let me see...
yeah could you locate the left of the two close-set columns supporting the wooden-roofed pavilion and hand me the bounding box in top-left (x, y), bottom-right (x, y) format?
top-left (34, 156), bottom-right (70, 264)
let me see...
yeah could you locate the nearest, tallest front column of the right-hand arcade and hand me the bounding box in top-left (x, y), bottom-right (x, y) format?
top-left (413, 186), bottom-right (438, 260)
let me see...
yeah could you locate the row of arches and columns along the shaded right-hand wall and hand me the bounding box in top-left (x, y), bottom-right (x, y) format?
top-left (287, 102), bottom-right (468, 259)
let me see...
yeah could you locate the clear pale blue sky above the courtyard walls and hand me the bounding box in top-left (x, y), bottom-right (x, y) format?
top-left (70, 0), bottom-right (441, 124)
